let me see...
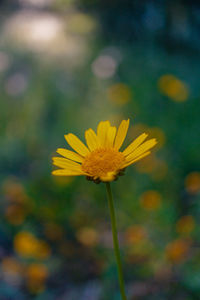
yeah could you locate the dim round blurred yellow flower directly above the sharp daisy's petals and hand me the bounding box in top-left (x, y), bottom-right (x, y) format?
top-left (107, 83), bottom-right (131, 105)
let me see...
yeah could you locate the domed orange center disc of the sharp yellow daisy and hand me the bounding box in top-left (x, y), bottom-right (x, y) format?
top-left (82, 148), bottom-right (125, 177)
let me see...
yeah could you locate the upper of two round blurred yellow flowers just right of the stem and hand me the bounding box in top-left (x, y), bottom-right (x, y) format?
top-left (140, 190), bottom-right (161, 210)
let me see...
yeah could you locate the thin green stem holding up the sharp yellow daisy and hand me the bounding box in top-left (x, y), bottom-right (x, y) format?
top-left (106, 182), bottom-right (127, 300)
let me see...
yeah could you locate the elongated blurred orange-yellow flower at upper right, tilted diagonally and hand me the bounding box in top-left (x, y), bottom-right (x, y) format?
top-left (158, 74), bottom-right (189, 102)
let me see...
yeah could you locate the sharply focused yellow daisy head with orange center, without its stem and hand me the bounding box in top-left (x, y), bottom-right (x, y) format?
top-left (52, 120), bottom-right (157, 183)
